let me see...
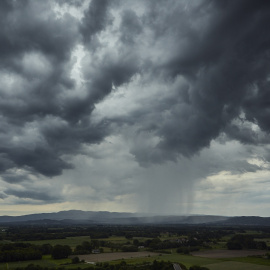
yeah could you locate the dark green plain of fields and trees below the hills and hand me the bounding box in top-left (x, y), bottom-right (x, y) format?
top-left (0, 225), bottom-right (270, 270)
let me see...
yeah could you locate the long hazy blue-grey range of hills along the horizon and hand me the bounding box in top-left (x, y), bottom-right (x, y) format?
top-left (0, 210), bottom-right (270, 226)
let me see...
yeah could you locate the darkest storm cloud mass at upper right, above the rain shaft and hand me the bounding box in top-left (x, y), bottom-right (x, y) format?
top-left (104, 0), bottom-right (270, 165)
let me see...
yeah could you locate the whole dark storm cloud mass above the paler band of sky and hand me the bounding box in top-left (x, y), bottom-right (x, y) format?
top-left (0, 0), bottom-right (270, 209)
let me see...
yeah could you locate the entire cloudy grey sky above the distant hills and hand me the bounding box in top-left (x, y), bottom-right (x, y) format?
top-left (0, 0), bottom-right (270, 216)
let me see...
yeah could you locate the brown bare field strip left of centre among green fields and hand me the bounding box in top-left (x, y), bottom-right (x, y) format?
top-left (78, 251), bottom-right (158, 262)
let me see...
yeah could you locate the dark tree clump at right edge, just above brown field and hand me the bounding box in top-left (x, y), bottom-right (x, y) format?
top-left (227, 234), bottom-right (267, 250)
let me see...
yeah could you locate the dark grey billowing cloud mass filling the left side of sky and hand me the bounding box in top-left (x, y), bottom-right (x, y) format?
top-left (0, 1), bottom-right (118, 181)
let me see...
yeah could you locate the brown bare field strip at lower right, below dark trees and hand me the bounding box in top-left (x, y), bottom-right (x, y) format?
top-left (191, 250), bottom-right (267, 258)
